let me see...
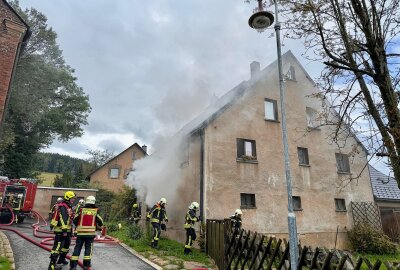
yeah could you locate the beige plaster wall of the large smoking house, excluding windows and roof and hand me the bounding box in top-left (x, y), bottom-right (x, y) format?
top-left (173, 54), bottom-right (373, 248)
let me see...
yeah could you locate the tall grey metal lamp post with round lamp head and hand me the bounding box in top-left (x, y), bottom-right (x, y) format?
top-left (249, 0), bottom-right (299, 270)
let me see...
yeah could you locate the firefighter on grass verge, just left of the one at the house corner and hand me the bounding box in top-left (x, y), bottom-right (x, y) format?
top-left (147, 198), bottom-right (168, 248)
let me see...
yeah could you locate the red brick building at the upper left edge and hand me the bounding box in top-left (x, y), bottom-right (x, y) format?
top-left (0, 0), bottom-right (30, 132)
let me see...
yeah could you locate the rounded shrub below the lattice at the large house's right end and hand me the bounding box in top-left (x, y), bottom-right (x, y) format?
top-left (348, 224), bottom-right (396, 254)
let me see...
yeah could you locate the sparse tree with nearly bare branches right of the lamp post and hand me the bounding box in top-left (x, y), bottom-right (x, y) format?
top-left (253, 0), bottom-right (400, 187)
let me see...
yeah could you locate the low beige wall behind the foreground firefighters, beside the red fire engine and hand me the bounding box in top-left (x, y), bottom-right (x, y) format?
top-left (33, 186), bottom-right (97, 218)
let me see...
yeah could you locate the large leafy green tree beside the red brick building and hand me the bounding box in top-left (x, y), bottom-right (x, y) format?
top-left (1, 1), bottom-right (91, 177)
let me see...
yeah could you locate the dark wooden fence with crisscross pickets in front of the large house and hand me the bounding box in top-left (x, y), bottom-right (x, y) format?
top-left (206, 220), bottom-right (400, 270)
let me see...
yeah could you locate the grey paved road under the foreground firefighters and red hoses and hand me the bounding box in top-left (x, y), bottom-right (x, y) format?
top-left (4, 221), bottom-right (154, 270)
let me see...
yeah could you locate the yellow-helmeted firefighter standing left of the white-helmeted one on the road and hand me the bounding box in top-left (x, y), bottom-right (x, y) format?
top-left (48, 191), bottom-right (76, 270)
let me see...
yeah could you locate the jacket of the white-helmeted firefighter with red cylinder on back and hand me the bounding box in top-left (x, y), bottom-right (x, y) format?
top-left (74, 204), bottom-right (104, 237)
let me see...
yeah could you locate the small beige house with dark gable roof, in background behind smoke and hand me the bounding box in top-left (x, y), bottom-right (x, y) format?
top-left (87, 143), bottom-right (147, 192)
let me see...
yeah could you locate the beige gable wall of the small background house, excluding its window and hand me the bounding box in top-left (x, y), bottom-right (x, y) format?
top-left (90, 145), bottom-right (145, 192)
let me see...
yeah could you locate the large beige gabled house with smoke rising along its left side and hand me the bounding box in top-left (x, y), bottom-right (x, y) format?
top-left (135, 51), bottom-right (373, 248)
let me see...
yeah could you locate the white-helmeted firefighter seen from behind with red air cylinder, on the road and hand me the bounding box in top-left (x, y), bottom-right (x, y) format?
top-left (70, 196), bottom-right (103, 270)
